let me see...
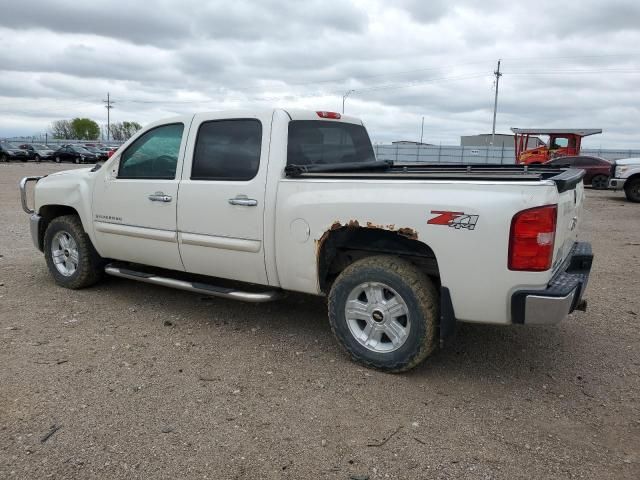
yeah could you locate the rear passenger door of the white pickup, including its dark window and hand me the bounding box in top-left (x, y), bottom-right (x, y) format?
top-left (178, 113), bottom-right (272, 285)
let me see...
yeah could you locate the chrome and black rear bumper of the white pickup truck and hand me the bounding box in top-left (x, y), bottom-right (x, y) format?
top-left (511, 242), bottom-right (593, 325)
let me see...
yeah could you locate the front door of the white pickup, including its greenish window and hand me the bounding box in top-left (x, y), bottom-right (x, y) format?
top-left (93, 122), bottom-right (188, 270)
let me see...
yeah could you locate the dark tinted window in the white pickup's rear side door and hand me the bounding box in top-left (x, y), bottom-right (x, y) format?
top-left (191, 119), bottom-right (262, 181)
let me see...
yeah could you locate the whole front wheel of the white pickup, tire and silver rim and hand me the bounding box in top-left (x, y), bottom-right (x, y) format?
top-left (44, 215), bottom-right (104, 289)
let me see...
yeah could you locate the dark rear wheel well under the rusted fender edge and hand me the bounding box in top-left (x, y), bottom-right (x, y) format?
top-left (317, 222), bottom-right (440, 293)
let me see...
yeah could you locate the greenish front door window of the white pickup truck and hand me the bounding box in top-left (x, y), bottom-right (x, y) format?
top-left (118, 123), bottom-right (184, 180)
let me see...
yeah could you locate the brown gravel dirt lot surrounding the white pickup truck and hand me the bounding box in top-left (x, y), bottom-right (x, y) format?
top-left (0, 163), bottom-right (640, 479)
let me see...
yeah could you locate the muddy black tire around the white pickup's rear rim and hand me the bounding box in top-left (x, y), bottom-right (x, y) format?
top-left (329, 256), bottom-right (439, 372)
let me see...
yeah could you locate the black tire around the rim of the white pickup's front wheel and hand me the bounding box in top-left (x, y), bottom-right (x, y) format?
top-left (44, 215), bottom-right (105, 290)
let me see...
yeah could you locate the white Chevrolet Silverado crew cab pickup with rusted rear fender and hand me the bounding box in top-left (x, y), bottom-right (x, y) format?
top-left (20, 109), bottom-right (592, 371)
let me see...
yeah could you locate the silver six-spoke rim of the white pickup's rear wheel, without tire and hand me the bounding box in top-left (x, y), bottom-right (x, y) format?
top-left (345, 282), bottom-right (411, 353)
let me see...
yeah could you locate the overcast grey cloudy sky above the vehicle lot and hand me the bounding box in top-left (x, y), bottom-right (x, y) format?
top-left (0, 0), bottom-right (640, 148)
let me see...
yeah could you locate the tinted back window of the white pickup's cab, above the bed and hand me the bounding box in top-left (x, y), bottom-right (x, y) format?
top-left (287, 120), bottom-right (376, 165)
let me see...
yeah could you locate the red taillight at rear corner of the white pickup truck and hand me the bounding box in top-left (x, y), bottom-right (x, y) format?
top-left (509, 205), bottom-right (558, 272)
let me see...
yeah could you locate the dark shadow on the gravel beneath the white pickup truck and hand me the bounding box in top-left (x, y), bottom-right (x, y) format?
top-left (98, 279), bottom-right (588, 380)
